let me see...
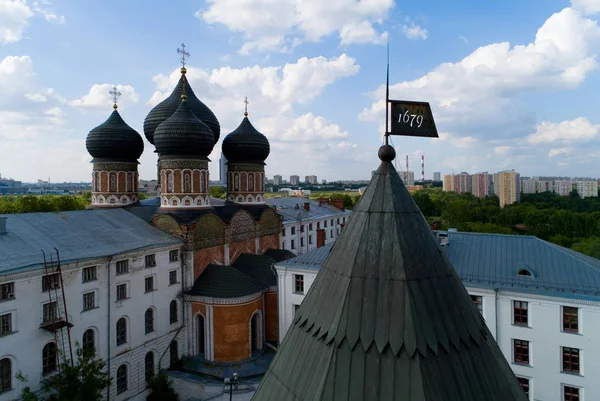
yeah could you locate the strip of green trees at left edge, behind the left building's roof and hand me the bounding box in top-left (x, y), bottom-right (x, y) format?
top-left (0, 194), bottom-right (91, 214)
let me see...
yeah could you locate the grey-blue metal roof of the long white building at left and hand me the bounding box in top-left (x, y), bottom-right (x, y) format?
top-left (0, 208), bottom-right (182, 274)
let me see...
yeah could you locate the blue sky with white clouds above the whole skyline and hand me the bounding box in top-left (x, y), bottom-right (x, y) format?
top-left (0, 0), bottom-right (600, 182)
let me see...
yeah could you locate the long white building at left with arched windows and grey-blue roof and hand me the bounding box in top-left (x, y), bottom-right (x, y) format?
top-left (0, 209), bottom-right (187, 401)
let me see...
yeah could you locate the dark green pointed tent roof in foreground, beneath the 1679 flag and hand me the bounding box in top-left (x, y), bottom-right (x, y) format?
top-left (252, 148), bottom-right (527, 401)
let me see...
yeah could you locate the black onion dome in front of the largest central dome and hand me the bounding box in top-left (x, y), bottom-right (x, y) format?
top-left (154, 101), bottom-right (215, 156)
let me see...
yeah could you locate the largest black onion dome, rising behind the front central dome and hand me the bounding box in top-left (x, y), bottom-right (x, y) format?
top-left (144, 75), bottom-right (221, 144)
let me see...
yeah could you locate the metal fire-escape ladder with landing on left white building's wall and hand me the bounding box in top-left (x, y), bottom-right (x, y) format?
top-left (40, 248), bottom-right (73, 368)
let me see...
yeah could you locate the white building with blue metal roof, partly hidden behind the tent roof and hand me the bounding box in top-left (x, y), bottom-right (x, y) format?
top-left (275, 232), bottom-right (600, 401)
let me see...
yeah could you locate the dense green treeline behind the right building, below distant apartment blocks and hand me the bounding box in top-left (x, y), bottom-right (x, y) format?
top-left (413, 189), bottom-right (600, 258)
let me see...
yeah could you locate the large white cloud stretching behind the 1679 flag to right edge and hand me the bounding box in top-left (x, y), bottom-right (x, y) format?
top-left (359, 8), bottom-right (600, 138)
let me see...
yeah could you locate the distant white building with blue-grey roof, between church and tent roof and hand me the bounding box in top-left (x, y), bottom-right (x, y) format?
top-left (265, 197), bottom-right (351, 255)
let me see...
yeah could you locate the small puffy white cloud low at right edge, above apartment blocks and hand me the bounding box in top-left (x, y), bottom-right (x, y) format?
top-left (527, 117), bottom-right (600, 144)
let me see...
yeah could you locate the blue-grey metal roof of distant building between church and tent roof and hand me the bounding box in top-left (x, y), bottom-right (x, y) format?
top-left (265, 196), bottom-right (352, 222)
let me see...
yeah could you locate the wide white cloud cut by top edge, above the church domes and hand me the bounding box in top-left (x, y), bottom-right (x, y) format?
top-left (195, 0), bottom-right (394, 54)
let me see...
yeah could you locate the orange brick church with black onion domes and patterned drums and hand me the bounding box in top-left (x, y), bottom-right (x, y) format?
top-left (86, 62), bottom-right (294, 362)
